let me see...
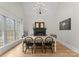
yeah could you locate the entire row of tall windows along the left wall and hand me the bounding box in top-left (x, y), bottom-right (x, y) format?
top-left (0, 15), bottom-right (23, 47)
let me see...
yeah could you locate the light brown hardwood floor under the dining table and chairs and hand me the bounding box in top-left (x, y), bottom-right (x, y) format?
top-left (1, 42), bottom-right (79, 57)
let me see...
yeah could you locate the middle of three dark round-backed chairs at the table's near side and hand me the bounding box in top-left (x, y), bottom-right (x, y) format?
top-left (34, 37), bottom-right (43, 53)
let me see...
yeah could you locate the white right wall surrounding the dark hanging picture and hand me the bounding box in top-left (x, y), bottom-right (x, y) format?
top-left (56, 2), bottom-right (79, 52)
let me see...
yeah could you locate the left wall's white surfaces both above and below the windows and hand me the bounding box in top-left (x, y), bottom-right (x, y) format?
top-left (0, 2), bottom-right (25, 55)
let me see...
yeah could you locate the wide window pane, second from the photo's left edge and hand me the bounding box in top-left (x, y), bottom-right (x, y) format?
top-left (6, 18), bottom-right (15, 43)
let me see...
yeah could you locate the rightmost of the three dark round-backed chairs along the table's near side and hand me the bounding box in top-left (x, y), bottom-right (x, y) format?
top-left (44, 36), bottom-right (54, 53)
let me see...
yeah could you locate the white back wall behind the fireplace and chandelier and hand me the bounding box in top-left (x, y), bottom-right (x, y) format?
top-left (23, 2), bottom-right (58, 34)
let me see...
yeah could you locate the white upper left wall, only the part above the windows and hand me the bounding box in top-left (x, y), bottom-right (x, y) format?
top-left (0, 2), bottom-right (24, 19)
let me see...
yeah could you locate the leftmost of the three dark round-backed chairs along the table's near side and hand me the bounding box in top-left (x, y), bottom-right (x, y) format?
top-left (25, 37), bottom-right (34, 53)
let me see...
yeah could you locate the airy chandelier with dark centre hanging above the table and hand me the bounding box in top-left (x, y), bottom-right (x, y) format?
top-left (33, 2), bottom-right (47, 15)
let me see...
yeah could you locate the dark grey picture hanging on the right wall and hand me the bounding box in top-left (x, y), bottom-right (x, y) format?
top-left (59, 18), bottom-right (71, 30)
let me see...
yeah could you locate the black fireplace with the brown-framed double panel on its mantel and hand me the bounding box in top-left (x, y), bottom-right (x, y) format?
top-left (33, 22), bottom-right (46, 36)
